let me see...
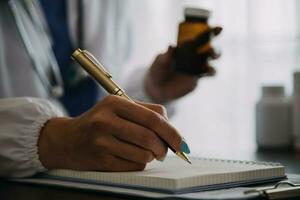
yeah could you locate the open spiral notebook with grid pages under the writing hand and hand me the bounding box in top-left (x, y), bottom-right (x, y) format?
top-left (44, 157), bottom-right (286, 193)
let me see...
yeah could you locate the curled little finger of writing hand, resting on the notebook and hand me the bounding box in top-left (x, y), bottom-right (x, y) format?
top-left (98, 155), bottom-right (146, 172)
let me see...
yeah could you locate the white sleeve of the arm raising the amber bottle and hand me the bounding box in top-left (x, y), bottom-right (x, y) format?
top-left (125, 67), bottom-right (176, 117)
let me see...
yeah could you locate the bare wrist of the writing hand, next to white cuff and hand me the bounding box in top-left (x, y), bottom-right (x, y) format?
top-left (38, 117), bottom-right (72, 169)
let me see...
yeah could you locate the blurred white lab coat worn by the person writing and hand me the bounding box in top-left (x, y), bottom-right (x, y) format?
top-left (0, 0), bottom-right (157, 177)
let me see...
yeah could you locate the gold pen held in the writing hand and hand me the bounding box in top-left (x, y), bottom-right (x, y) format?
top-left (72, 48), bottom-right (192, 164)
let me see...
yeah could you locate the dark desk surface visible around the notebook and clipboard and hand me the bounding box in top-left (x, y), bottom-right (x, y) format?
top-left (0, 152), bottom-right (300, 200)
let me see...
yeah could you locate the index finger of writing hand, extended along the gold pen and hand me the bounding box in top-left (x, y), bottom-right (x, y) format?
top-left (112, 97), bottom-right (182, 151)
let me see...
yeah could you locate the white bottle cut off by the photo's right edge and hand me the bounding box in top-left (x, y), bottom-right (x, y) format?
top-left (293, 72), bottom-right (300, 151)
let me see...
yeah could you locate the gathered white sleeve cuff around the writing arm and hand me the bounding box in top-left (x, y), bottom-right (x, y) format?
top-left (0, 98), bottom-right (63, 177)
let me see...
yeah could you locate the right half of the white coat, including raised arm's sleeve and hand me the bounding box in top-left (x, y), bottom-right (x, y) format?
top-left (68, 0), bottom-right (154, 102)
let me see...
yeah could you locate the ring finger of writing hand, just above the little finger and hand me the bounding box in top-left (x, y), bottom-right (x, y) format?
top-left (98, 136), bottom-right (154, 164)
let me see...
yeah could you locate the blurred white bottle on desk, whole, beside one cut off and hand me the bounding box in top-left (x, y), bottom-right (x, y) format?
top-left (256, 86), bottom-right (292, 150)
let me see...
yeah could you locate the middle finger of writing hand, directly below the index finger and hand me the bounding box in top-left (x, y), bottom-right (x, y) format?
top-left (107, 115), bottom-right (167, 161)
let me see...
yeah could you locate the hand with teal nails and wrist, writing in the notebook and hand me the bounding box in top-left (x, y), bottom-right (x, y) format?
top-left (38, 49), bottom-right (189, 171)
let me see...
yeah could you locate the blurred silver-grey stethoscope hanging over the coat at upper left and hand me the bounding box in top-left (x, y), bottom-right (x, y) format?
top-left (8, 0), bottom-right (64, 98)
